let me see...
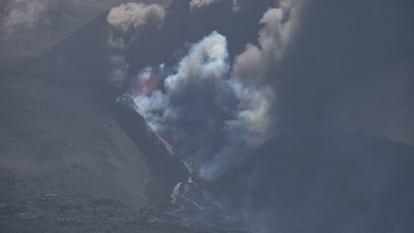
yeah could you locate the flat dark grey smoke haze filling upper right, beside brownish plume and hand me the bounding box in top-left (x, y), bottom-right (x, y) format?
top-left (275, 0), bottom-right (414, 144)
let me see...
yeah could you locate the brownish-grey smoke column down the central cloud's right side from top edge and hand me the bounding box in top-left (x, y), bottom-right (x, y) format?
top-left (201, 0), bottom-right (300, 177)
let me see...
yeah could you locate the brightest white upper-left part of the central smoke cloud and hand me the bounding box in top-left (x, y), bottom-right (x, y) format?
top-left (133, 32), bottom-right (229, 132)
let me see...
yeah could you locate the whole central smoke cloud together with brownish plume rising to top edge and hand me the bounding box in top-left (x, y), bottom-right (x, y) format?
top-left (118, 1), bottom-right (295, 179)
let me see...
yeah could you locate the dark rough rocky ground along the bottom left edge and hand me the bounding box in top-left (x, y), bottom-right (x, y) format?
top-left (0, 194), bottom-right (246, 233)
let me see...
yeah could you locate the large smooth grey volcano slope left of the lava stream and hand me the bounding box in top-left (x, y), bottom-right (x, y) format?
top-left (0, 3), bottom-right (191, 232)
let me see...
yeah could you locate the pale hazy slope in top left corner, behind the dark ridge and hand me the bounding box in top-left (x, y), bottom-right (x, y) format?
top-left (0, 0), bottom-right (170, 70)
